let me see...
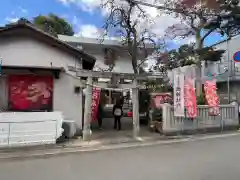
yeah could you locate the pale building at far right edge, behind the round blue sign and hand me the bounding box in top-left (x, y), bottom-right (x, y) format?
top-left (205, 35), bottom-right (240, 103)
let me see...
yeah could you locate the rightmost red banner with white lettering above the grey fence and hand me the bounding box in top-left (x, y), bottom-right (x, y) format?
top-left (204, 79), bottom-right (220, 116)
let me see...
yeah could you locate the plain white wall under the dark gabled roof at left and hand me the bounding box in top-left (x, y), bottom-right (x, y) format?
top-left (0, 37), bottom-right (82, 127)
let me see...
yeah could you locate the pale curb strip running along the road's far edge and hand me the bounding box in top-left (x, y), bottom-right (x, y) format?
top-left (0, 132), bottom-right (240, 161)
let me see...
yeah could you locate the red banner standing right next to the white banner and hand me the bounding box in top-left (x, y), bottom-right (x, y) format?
top-left (184, 78), bottom-right (197, 118)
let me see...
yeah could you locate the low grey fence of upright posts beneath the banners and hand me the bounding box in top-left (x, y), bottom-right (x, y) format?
top-left (163, 104), bottom-right (239, 132)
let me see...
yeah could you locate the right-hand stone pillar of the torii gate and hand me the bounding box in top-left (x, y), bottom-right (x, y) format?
top-left (132, 79), bottom-right (140, 138)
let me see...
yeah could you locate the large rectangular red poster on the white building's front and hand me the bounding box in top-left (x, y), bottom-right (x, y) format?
top-left (8, 75), bottom-right (53, 111)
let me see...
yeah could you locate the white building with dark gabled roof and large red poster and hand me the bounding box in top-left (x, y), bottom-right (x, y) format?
top-left (0, 23), bottom-right (95, 132)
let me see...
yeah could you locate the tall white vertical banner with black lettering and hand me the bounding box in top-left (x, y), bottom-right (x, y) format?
top-left (173, 74), bottom-right (184, 117)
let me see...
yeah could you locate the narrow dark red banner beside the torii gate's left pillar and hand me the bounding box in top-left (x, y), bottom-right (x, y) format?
top-left (92, 87), bottom-right (101, 121)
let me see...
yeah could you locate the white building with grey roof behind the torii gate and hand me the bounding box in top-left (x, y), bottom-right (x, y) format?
top-left (58, 35), bottom-right (154, 104)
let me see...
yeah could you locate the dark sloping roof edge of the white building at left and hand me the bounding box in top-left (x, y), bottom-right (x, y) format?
top-left (0, 22), bottom-right (96, 70)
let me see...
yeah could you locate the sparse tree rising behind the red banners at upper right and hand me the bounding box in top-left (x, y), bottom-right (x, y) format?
top-left (165, 0), bottom-right (239, 95)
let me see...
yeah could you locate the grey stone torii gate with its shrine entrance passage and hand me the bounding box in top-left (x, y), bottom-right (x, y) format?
top-left (69, 67), bottom-right (162, 140)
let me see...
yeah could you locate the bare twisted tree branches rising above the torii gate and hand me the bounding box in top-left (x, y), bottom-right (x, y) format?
top-left (103, 0), bottom-right (163, 73)
